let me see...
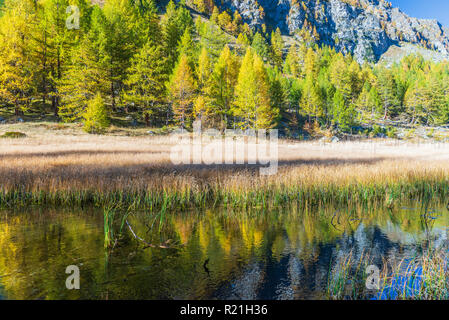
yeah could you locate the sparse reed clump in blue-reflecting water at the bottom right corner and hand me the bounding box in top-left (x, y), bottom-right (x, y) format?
top-left (327, 248), bottom-right (449, 300)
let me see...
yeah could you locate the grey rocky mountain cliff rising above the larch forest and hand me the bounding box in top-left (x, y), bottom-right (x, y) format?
top-left (216, 0), bottom-right (449, 62)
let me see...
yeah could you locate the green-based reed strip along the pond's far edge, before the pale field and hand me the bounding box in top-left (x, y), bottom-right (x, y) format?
top-left (0, 162), bottom-right (449, 210)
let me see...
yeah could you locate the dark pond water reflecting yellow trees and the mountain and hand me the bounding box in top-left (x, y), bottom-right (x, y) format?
top-left (0, 204), bottom-right (449, 300)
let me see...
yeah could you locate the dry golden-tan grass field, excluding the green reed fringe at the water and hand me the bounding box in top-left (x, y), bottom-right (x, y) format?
top-left (0, 123), bottom-right (449, 208)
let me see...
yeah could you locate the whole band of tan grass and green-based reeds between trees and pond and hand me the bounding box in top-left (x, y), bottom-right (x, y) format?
top-left (0, 124), bottom-right (449, 212)
